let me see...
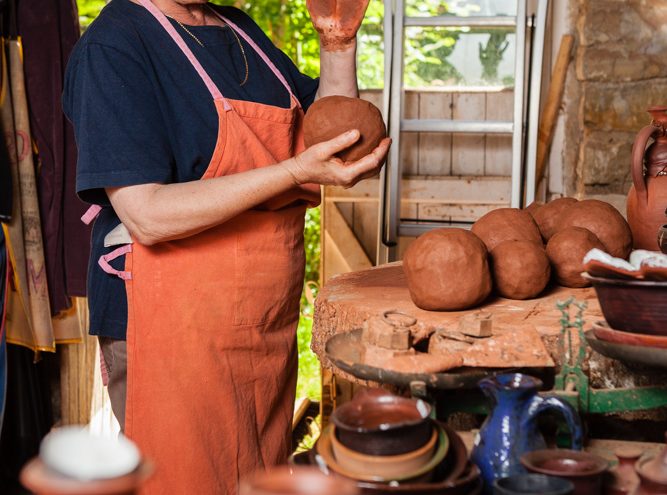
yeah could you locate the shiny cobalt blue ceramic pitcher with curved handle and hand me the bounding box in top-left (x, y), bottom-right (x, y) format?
top-left (472, 373), bottom-right (583, 487)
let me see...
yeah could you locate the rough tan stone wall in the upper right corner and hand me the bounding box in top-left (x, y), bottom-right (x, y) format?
top-left (556, 0), bottom-right (667, 202)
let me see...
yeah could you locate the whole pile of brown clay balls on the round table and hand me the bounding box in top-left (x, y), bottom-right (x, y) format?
top-left (403, 198), bottom-right (632, 311)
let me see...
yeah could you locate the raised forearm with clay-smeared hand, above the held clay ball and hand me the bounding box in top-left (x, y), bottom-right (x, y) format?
top-left (306, 0), bottom-right (369, 99)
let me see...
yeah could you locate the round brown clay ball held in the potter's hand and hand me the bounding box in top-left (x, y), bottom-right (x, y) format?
top-left (303, 96), bottom-right (387, 162)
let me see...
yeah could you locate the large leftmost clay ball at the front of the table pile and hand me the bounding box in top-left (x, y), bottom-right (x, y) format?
top-left (403, 228), bottom-right (491, 311)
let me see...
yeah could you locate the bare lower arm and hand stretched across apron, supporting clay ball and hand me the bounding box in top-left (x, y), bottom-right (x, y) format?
top-left (106, 131), bottom-right (390, 245)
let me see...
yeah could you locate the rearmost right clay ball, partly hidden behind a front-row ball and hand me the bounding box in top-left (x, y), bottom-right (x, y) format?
top-left (558, 199), bottom-right (632, 259)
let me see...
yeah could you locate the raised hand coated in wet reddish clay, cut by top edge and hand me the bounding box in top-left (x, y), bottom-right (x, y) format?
top-left (306, 0), bottom-right (369, 51)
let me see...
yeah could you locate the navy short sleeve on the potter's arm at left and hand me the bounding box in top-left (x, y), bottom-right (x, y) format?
top-left (63, 39), bottom-right (174, 204)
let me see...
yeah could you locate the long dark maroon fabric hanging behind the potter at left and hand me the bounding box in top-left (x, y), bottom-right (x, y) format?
top-left (17, 0), bottom-right (90, 314)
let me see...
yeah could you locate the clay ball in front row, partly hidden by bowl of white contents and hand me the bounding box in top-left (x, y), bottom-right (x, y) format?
top-left (547, 227), bottom-right (604, 287)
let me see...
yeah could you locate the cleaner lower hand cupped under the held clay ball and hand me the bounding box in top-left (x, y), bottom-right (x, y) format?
top-left (285, 129), bottom-right (391, 188)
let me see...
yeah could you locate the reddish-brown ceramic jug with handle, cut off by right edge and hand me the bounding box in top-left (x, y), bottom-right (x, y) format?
top-left (627, 106), bottom-right (667, 251)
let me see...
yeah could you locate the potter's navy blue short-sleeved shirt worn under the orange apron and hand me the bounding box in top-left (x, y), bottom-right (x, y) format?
top-left (63, 0), bottom-right (318, 339)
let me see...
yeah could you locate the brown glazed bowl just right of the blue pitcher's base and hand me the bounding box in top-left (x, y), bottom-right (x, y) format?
top-left (521, 449), bottom-right (609, 495)
